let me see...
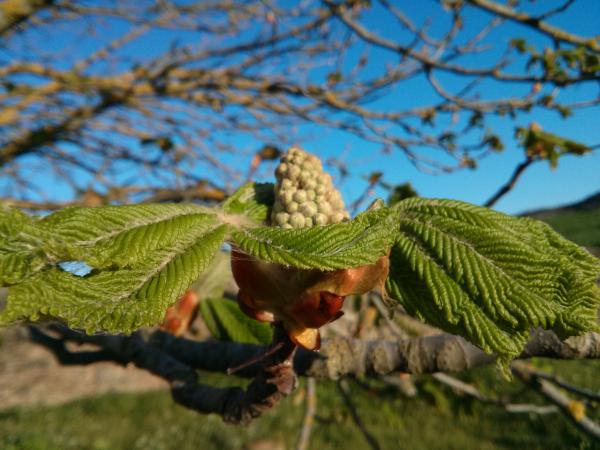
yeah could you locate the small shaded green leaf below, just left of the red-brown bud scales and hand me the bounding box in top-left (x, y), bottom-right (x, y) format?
top-left (200, 298), bottom-right (273, 344)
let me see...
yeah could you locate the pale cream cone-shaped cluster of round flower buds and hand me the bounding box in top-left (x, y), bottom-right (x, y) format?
top-left (271, 147), bottom-right (349, 228)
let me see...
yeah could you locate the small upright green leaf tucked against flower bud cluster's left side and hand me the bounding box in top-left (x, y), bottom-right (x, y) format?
top-left (223, 183), bottom-right (275, 224)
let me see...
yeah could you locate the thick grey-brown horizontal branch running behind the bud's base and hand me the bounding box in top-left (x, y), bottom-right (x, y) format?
top-left (31, 327), bottom-right (600, 379)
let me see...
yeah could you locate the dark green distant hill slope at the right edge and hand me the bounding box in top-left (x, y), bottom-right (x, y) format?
top-left (523, 192), bottom-right (600, 256)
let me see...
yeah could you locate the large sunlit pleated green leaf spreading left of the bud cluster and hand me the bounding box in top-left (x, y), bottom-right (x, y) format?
top-left (0, 205), bottom-right (227, 332)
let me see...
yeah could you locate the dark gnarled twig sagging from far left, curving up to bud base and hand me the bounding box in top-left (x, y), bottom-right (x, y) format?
top-left (29, 326), bottom-right (297, 424)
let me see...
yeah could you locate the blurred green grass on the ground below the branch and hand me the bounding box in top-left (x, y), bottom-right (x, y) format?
top-left (0, 360), bottom-right (600, 450)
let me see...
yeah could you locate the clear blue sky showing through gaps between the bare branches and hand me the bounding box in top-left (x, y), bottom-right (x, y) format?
top-left (4, 0), bottom-right (600, 213)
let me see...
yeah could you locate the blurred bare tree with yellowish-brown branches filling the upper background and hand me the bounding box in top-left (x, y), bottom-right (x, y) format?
top-left (0, 0), bottom-right (600, 209)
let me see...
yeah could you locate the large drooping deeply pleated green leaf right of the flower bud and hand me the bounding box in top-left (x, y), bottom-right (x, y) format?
top-left (387, 199), bottom-right (600, 363)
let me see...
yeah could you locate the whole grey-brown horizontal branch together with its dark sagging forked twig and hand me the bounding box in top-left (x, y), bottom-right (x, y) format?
top-left (29, 324), bottom-right (600, 423)
